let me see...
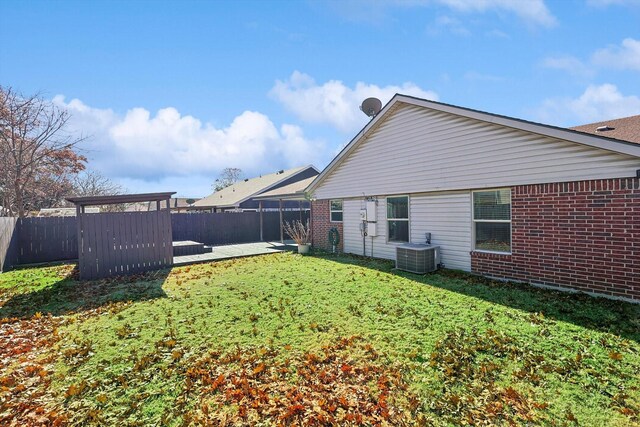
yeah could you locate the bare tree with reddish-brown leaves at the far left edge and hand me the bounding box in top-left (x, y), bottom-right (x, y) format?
top-left (0, 86), bottom-right (87, 217)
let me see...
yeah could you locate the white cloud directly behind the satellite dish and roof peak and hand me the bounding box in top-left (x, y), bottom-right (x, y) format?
top-left (271, 71), bottom-right (438, 133)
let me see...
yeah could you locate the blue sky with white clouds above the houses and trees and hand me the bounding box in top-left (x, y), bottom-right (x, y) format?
top-left (0, 0), bottom-right (640, 197)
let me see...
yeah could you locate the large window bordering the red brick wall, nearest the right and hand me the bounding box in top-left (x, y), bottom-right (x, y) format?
top-left (473, 188), bottom-right (511, 253)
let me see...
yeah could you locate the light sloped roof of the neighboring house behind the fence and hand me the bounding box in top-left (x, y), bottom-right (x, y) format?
top-left (192, 165), bottom-right (319, 208)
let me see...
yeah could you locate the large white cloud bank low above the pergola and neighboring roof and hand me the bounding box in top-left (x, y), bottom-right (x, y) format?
top-left (54, 96), bottom-right (327, 196)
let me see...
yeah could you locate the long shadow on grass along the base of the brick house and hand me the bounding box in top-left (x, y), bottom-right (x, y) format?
top-left (316, 252), bottom-right (640, 342)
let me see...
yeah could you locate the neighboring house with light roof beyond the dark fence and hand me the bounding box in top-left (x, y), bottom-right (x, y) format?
top-left (189, 165), bottom-right (320, 212)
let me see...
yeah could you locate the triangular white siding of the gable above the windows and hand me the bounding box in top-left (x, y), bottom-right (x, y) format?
top-left (314, 104), bottom-right (640, 199)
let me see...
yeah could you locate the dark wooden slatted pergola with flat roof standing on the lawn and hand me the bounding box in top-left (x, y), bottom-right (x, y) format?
top-left (67, 192), bottom-right (175, 279)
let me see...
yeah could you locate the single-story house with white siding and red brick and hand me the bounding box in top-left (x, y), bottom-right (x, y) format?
top-left (306, 94), bottom-right (640, 301)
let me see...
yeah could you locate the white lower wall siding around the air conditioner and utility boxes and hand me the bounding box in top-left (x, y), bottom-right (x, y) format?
top-left (343, 191), bottom-right (471, 271)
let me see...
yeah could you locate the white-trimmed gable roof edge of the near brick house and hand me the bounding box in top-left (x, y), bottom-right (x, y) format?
top-left (305, 94), bottom-right (640, 193)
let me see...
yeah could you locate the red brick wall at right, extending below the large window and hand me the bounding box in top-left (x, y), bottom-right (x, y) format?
top-left (471, 178), bottom-right (640, 300)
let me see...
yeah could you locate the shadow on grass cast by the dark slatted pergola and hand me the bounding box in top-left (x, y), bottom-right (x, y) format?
top-left (0, 269), bottom-right (171, 318)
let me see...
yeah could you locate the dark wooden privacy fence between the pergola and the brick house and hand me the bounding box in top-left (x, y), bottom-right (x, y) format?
top-left (171, 211), bottom-right (309, 245)
